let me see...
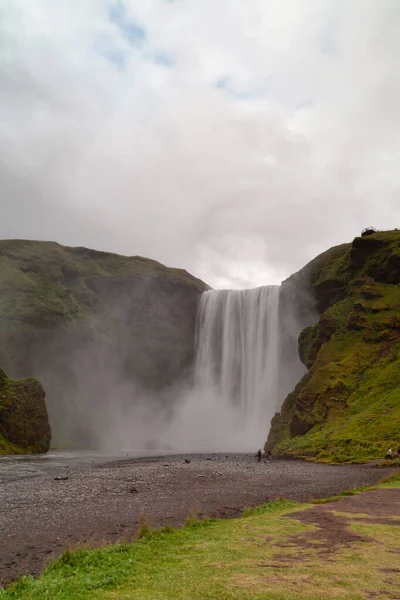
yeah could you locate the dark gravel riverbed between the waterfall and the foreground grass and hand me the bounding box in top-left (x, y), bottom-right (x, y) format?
top-left (0, 455), bottom-right (393, 585)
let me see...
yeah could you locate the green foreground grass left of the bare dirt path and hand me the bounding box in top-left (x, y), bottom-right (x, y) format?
top-left (0, 501), bottom-right (310, 600)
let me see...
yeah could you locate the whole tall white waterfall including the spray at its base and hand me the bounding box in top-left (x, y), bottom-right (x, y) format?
top-left (164, 285), bottom-right (306, 452)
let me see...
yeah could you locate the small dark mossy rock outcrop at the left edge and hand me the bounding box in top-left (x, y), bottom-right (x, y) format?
top-left (0, 369), bottom-right (51, 454)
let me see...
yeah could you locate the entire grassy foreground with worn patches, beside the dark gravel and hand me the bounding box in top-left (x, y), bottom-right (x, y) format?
top-left (0, 477), bottom-right (400, 600)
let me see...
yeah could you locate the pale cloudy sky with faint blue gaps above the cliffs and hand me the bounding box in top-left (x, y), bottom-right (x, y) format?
top-left (0, 0), bottom-right (400, 288)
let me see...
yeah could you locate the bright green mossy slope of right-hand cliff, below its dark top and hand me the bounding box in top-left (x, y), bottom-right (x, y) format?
top-left (269, 264), bottom-right (400, 466)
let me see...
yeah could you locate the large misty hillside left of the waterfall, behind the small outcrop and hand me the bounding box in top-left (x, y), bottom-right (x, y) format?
top-left (0, 240), bottom-right (207, 447)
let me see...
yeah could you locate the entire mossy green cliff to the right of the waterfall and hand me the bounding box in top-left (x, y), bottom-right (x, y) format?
top-left (266, 231), bottom-right (400, 461)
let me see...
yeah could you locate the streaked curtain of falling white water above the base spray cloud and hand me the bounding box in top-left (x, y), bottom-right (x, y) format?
top-left (195, 286), bottom-right (280, 436)
